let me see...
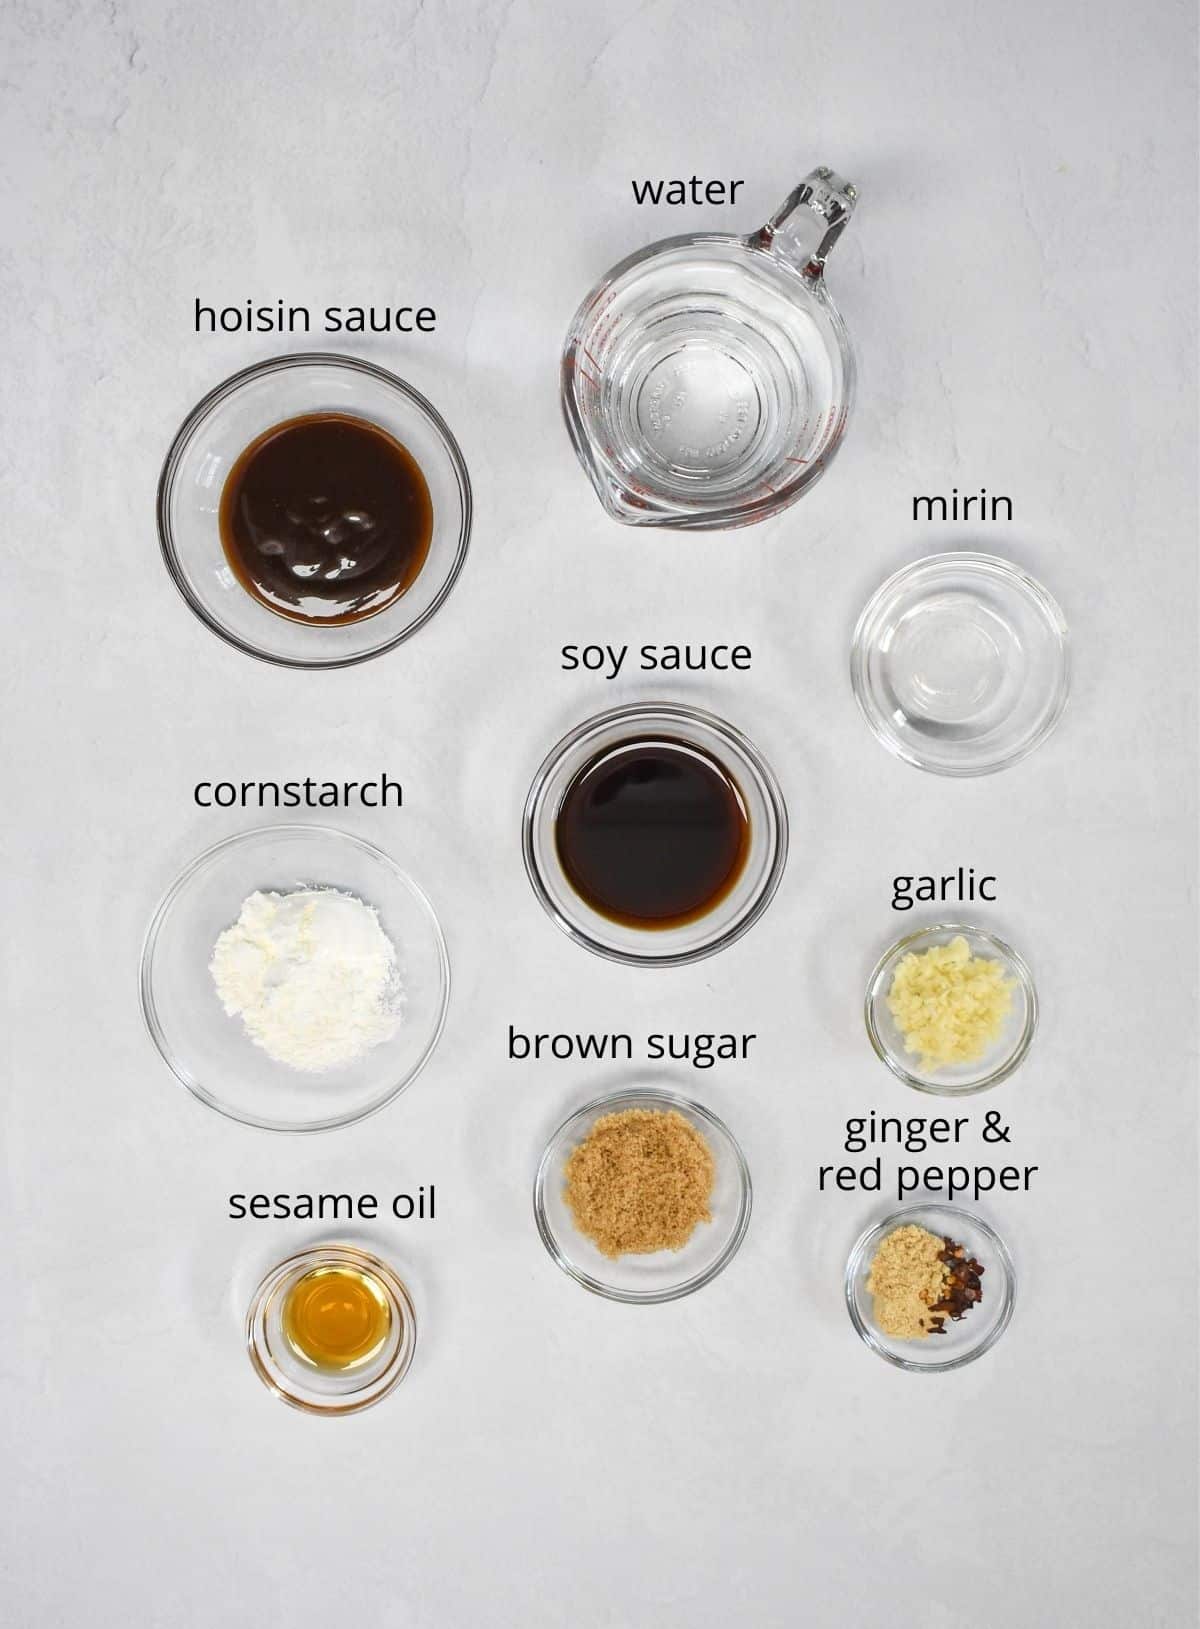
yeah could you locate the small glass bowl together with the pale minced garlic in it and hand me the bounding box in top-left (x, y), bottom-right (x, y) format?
top-left (866, 922), bottom-right (1037, 1096)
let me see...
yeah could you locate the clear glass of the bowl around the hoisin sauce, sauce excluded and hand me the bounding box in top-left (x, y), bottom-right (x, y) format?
top-left (158, 352), bottom-right (471, 668)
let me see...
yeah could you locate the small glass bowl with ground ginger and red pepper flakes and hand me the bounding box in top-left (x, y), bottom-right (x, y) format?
top-left (845, 1202), bottom-right (1016, 1373)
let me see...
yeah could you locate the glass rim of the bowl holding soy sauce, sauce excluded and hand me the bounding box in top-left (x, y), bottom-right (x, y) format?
top-left (521, 702), bottom-right (788, 968)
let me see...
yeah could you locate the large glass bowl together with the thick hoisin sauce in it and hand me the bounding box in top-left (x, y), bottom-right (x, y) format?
top-left (158, 352), bottom-right (472, 668)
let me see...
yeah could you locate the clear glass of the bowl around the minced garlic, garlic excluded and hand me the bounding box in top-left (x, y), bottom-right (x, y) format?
top-left (865, 922), bottom-right (1037, 1098)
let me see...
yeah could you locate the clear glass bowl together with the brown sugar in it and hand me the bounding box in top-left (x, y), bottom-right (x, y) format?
top-left (534, 1087), bottom-right (751, 1303)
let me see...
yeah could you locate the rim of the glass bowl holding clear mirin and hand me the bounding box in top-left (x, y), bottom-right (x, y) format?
top-left (850, 549), bottom-right (1071, 780)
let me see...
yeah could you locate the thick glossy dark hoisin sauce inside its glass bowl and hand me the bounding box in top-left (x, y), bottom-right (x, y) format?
top-left (220, 412), bottom-right (433, 624)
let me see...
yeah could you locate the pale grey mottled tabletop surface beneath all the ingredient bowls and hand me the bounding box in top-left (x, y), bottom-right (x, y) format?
top-left (0, 0), bottom-right (1197, 1629)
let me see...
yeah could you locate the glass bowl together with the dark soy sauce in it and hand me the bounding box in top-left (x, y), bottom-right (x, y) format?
top-left (523, 702), bottom-right (788, 968)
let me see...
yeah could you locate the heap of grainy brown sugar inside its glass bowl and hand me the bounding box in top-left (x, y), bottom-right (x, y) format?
top-left (563, 1109), bottom-right (716, 1256)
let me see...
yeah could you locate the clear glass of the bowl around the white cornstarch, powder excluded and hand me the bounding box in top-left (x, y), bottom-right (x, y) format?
top-left (142, 826), bottom-right (449, 1131)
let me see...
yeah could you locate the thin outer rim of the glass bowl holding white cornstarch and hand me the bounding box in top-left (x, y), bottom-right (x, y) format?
top-left (138, 821), bottom-right (451, 1137)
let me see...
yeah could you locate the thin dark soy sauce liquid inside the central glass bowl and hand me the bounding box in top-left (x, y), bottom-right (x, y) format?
top-left (555, 741), bottom-right (751, 929)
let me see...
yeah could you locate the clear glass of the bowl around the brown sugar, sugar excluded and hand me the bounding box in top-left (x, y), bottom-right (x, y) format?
top-left (534, 1087), bottom-right (751, 1305)
